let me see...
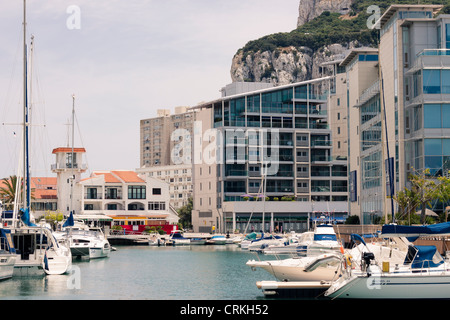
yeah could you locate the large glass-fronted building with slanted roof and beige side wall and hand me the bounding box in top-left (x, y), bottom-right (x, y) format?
top-left (192, 77), bottom-right (348, 232)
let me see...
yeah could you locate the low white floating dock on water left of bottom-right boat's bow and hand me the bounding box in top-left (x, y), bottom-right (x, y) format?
top-left (256, 281), bottom-right (331, 298)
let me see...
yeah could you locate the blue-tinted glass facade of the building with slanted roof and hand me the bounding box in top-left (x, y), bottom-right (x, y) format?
top-left (212, 79), bottom-right (348, 206)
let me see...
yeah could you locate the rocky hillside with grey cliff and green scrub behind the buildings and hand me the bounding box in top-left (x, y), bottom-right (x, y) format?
top-left (231, 0), bottom-right (448, 85)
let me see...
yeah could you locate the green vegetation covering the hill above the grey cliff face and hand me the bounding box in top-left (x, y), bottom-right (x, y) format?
top-left (240, 0), bottom-right (450, 57)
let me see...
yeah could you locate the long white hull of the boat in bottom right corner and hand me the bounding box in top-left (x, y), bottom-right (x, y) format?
top-left (325, 273), bottom-right (450, 299)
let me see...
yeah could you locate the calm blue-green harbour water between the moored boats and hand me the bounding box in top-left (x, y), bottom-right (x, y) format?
top-left (0, 245), bottom-right (275, 300)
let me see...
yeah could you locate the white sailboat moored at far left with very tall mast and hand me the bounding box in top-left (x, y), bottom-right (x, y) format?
top-left (7, 0), bottom-right (72, 276)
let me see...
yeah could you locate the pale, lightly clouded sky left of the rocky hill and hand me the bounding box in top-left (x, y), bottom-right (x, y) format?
top-left (0, 0), bottom-right (299, 179)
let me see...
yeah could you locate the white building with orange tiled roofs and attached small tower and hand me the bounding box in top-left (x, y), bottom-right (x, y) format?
top-left (51, 148), bottom-right (178, 227)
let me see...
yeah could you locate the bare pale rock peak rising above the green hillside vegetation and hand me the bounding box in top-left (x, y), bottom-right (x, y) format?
top-left (297, 0), bottom-right (352, 27)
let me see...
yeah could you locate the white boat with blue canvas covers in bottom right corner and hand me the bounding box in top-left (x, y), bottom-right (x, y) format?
top-left (325, 223), bottom-right (450, 299)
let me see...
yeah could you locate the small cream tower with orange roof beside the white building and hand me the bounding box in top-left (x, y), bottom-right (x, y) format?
top-left (52, 147), bottom-right (87, 216)
